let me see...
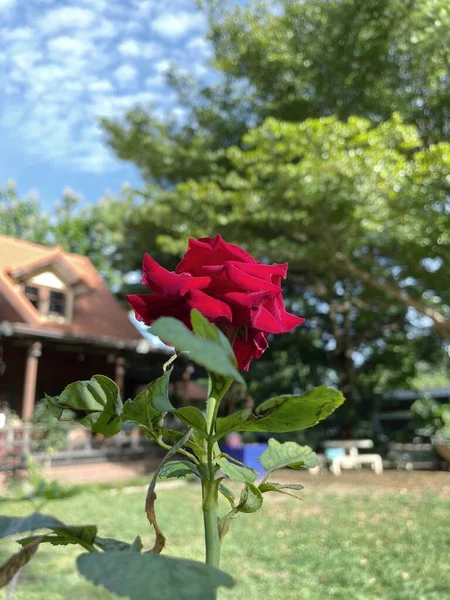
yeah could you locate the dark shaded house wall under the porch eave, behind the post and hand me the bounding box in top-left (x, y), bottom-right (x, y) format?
top-left (0, 338), bottom-right (115, 415)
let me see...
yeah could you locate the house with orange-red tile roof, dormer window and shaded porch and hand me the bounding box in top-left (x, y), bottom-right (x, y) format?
top-left (0, 235), bottom-right (160, 421)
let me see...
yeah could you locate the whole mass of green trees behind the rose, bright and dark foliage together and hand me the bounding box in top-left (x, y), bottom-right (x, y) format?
top-left (96, 0), bottom-right (450, 408)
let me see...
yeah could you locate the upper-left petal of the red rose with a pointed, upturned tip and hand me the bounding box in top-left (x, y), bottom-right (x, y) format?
top-left (141, 254), bottom-right (211, 296)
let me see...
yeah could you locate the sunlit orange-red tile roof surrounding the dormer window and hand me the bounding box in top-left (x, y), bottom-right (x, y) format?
top-left (0, 235), bottom-right (142, 342)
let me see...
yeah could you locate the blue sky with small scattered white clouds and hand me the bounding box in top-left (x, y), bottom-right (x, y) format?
top-left (0, 0), bottom-right (210, 207)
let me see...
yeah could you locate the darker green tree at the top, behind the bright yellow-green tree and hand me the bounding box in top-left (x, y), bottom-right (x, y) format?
top-left (102, 0), bottom-right (450, 187)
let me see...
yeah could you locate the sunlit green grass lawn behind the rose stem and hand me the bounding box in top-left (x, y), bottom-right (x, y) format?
top-left (0, 474), bottom-right (450, 600)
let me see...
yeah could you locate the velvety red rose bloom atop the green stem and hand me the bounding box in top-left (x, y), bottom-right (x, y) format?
top-left (127, 235), bottom-right (304, 370)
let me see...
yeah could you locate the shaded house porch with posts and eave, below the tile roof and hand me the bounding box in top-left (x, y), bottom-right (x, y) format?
top-left (0, 322), bottom-right (174, 422)
